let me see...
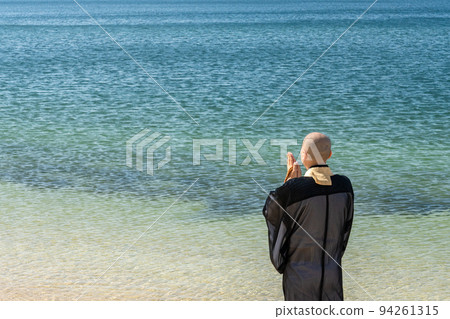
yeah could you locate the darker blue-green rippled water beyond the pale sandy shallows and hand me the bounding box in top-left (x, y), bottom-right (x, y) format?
top-left (0, 0), bottom-right (450, 216)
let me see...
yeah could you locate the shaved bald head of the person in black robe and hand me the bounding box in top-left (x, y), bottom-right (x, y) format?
top-left (301, 132), bottom-right (331, 168)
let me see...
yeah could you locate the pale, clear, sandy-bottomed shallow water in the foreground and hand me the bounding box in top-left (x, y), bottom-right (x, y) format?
top-left (0, 184), bottom-right (450, 300)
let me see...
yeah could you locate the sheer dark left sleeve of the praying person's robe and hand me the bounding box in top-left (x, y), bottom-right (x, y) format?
top-left (263, 185), bottom-right (289, 274)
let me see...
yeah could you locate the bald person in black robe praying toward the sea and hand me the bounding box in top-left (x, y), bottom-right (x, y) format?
top-left (263, 132), bottom-right (354, 301)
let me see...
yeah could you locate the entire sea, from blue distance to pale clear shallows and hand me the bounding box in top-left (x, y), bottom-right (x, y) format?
top-left (0, 0), bottom-right (450, 300)
